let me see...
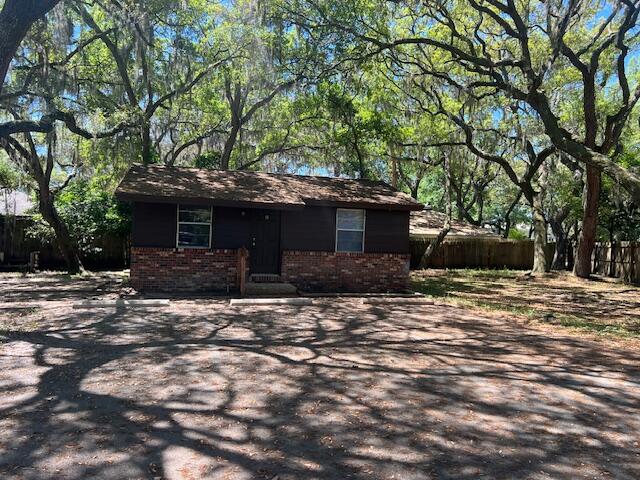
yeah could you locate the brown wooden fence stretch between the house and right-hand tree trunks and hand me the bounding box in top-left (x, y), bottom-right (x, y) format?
top-left (410, 238), bottom-right (555, 270)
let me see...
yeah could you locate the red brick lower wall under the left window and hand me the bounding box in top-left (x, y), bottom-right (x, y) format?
top-left (131, 247), bottom-right (238, 292)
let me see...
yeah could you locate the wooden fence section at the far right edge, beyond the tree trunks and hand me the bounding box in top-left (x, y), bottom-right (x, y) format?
top-left (592, 242), bottom-right (640, 283)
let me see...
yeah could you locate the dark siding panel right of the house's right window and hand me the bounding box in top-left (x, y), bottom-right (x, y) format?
top-left (364, 210), bottom-right (409, 253)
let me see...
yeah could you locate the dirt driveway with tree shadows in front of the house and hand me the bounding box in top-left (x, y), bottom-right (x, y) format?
top-left (0, 278), bottom-right (640, 480)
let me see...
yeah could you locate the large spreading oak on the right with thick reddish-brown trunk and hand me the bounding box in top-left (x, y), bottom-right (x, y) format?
top-left (292, 0), bottom-right (640, 276)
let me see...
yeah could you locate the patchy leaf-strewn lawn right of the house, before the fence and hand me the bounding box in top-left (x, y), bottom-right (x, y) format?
top-left (412, 270), bottom-right (640, 338)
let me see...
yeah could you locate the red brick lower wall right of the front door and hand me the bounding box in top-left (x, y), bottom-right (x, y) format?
top-left (281, 251), bottom-right (410, 292)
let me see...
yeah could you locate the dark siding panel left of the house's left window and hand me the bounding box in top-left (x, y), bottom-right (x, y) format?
top-left (132, 203), bottom-right (177, 248)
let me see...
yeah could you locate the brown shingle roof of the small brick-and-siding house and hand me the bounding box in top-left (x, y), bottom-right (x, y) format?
top-left (116, 165), bottom-right (422, 210)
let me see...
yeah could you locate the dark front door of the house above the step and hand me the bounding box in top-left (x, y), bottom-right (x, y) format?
top-left (249, 210), bottom-right (280, 274)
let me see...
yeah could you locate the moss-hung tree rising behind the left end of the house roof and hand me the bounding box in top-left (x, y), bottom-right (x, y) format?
top-left (73, 1), bottom-right (232, 164)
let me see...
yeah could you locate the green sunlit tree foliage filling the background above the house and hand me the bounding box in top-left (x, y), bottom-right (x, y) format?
top-left (0, 0), bottom-right (640, 266)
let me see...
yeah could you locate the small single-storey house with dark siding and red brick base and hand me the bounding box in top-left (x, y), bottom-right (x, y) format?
top-left (116, 165), bottom-right (423, 292)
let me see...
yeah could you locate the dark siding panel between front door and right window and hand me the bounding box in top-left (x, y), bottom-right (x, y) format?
top-left (280, 207), bottom-right (336, 252)
